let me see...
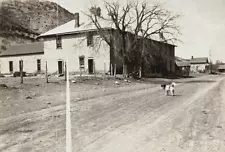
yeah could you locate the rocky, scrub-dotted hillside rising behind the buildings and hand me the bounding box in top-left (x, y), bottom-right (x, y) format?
top-left (0, 0), bottom-right (74, 51)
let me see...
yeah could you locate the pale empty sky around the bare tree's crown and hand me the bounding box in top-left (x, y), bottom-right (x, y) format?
top-left (0, 0), bottom-right (225, 62)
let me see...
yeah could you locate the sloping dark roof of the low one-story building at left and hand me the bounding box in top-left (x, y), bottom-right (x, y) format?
top-left (0, 42), bottom-right (44, 57)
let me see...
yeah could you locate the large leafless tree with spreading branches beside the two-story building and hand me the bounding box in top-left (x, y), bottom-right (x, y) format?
top-left (86, 2), bottom-right (180, 76)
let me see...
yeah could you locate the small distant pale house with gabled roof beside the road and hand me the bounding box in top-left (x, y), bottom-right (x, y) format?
top-left (189, 56), bottom-right (209, 73)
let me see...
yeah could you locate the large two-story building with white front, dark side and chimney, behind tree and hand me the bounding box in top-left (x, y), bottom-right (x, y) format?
top-left (39, 13), bottom-right (175, 74)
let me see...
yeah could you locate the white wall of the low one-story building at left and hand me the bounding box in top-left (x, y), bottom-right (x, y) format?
top-left (0, 54), bottom-right (45, 74)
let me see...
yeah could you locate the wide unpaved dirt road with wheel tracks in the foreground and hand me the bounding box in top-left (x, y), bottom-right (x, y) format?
top-left (0, 76), bottom-right (225, 152)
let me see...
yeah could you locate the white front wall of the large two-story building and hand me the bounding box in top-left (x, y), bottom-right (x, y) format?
top-left (44, 35), bottom-right (110, 73)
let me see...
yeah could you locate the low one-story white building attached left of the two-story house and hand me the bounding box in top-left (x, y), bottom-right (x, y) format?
top-left (0, 42), bottom-right (45, 75)
